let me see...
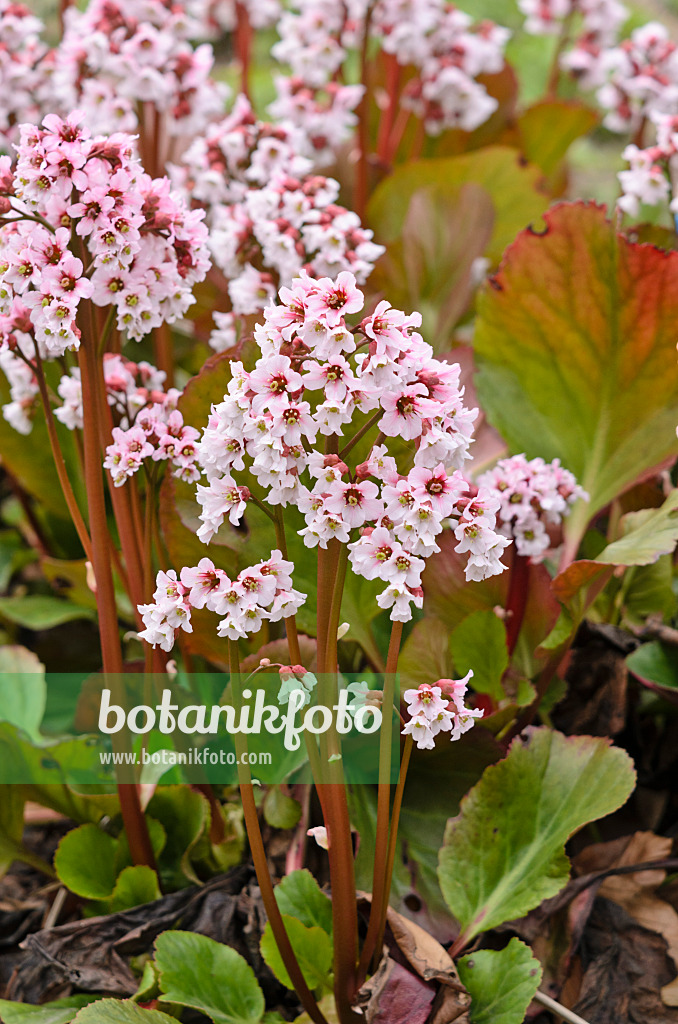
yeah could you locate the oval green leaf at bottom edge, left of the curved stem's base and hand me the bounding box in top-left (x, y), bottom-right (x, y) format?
top-left (156, 932), bottom-right (265, 1024)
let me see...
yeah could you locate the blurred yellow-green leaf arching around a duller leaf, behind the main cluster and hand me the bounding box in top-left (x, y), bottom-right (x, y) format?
top-left (368, 145), bottom-right (548, 263)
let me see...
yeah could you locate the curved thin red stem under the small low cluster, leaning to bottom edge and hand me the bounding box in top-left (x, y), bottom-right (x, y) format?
top-left (228, 640), bottom-right (327, 1024)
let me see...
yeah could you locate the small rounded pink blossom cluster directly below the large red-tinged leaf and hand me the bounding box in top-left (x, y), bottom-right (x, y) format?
top-left (477, 455), bottom-right (589, 558)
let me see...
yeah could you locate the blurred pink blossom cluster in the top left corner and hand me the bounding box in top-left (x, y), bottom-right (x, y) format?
top-left (0, 0), bottom-right (50, 151)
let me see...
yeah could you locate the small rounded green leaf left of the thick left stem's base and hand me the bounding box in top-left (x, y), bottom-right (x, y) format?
top-left (54, 824), bottom-right (118, 899)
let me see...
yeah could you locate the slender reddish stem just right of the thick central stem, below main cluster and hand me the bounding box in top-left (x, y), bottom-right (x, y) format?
top-left (358, 622), bottom-right (402, 978)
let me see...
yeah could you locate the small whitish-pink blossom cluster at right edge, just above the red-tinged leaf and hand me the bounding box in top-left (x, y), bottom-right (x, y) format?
top-left (617, 114), bottom-right (678, 217)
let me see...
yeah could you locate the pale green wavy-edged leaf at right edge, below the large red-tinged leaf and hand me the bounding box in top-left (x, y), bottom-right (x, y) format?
top-left (595, 489), bottom-right (678, 565)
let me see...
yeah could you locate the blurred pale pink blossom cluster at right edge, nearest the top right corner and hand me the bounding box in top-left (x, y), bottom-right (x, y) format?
top-left (562, 22), bottom-right (678, 132)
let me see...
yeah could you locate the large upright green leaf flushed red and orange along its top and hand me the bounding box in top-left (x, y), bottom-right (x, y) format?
top-left (474, 203), bottom-right (678, 549)
